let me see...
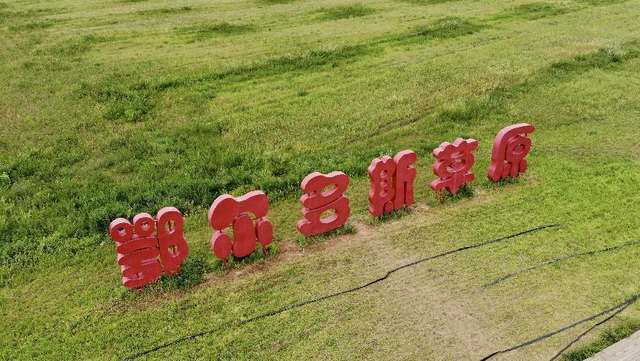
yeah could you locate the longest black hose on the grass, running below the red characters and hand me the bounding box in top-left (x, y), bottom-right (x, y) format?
top-left (123, 224), bottom-right (560, 360)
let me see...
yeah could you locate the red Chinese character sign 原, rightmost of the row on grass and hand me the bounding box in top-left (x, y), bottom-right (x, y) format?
top-left (489, 123), bottom-right (536, 182)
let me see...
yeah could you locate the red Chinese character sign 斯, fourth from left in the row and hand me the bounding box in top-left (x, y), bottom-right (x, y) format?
top-left (367, 150), bottom-right (417, 217)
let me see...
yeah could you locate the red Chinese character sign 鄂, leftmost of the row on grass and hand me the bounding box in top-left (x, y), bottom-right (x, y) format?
top-left (109, 207), bottom-right (189, 288)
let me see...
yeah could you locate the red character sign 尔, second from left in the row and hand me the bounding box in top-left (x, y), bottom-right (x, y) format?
top-left (209, 191), bottom-right (273, 263)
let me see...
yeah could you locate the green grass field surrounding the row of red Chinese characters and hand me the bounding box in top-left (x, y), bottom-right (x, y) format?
top-left (0, 0), bottom-right (640, 360)
